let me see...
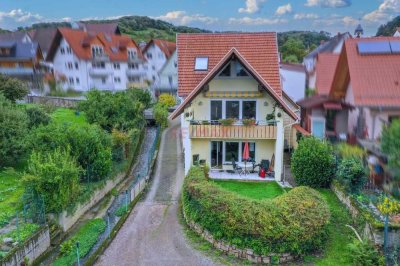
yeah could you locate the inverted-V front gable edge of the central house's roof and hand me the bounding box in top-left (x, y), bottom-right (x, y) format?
top-left (171, 48), bottom-right (298, 120)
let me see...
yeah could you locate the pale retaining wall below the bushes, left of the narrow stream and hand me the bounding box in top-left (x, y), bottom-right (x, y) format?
top-left (57, 173), bottom-right (126, 232)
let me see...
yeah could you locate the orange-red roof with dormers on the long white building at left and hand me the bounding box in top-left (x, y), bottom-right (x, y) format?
top-left (48, 28), bottom-right (144, 61)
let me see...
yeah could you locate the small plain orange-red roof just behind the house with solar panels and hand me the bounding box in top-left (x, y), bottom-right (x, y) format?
top-left (315, 53), bottom-right (339, 95)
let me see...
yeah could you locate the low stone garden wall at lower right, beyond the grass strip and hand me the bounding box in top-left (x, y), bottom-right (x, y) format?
top-left (331, 183), bottom-right (400, 247)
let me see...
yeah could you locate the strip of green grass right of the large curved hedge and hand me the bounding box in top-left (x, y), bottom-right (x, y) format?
top-left (306, 189), bottom-right (355, 266)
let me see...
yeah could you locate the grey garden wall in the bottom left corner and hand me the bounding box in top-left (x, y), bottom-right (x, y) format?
top-left (0, 226), bottom-right (50, 266)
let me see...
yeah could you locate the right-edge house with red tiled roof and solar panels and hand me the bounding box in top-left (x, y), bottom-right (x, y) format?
top-left (329, 37), bottom-right (400, 140)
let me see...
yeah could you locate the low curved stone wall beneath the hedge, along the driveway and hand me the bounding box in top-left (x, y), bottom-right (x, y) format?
top-left (183, 211), bottom-right (295, 264)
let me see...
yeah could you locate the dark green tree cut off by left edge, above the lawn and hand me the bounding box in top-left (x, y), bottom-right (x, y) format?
top-left (0, 93), bottom-right (28, 167)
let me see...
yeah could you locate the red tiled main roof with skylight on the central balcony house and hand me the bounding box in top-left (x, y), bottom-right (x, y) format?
top-left (177, 32), bottom-right (282, 97)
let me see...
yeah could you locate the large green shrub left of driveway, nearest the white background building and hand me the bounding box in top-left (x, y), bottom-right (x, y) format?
top-left (79, 90), bottom-right (145, 132)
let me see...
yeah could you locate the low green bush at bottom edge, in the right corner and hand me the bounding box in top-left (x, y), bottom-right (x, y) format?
top-left (348, 239), bottom-right (385, 266)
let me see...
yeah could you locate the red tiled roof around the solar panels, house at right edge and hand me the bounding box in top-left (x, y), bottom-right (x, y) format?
top-left (330, 37), bottom-right (400, 107)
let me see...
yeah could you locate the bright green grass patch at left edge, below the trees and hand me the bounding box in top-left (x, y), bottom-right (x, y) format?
top-left (0, 168), bottom-right (24, 227)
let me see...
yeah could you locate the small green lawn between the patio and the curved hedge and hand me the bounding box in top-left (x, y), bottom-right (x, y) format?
top-left (213, 180), bottom-right (285, 200)
